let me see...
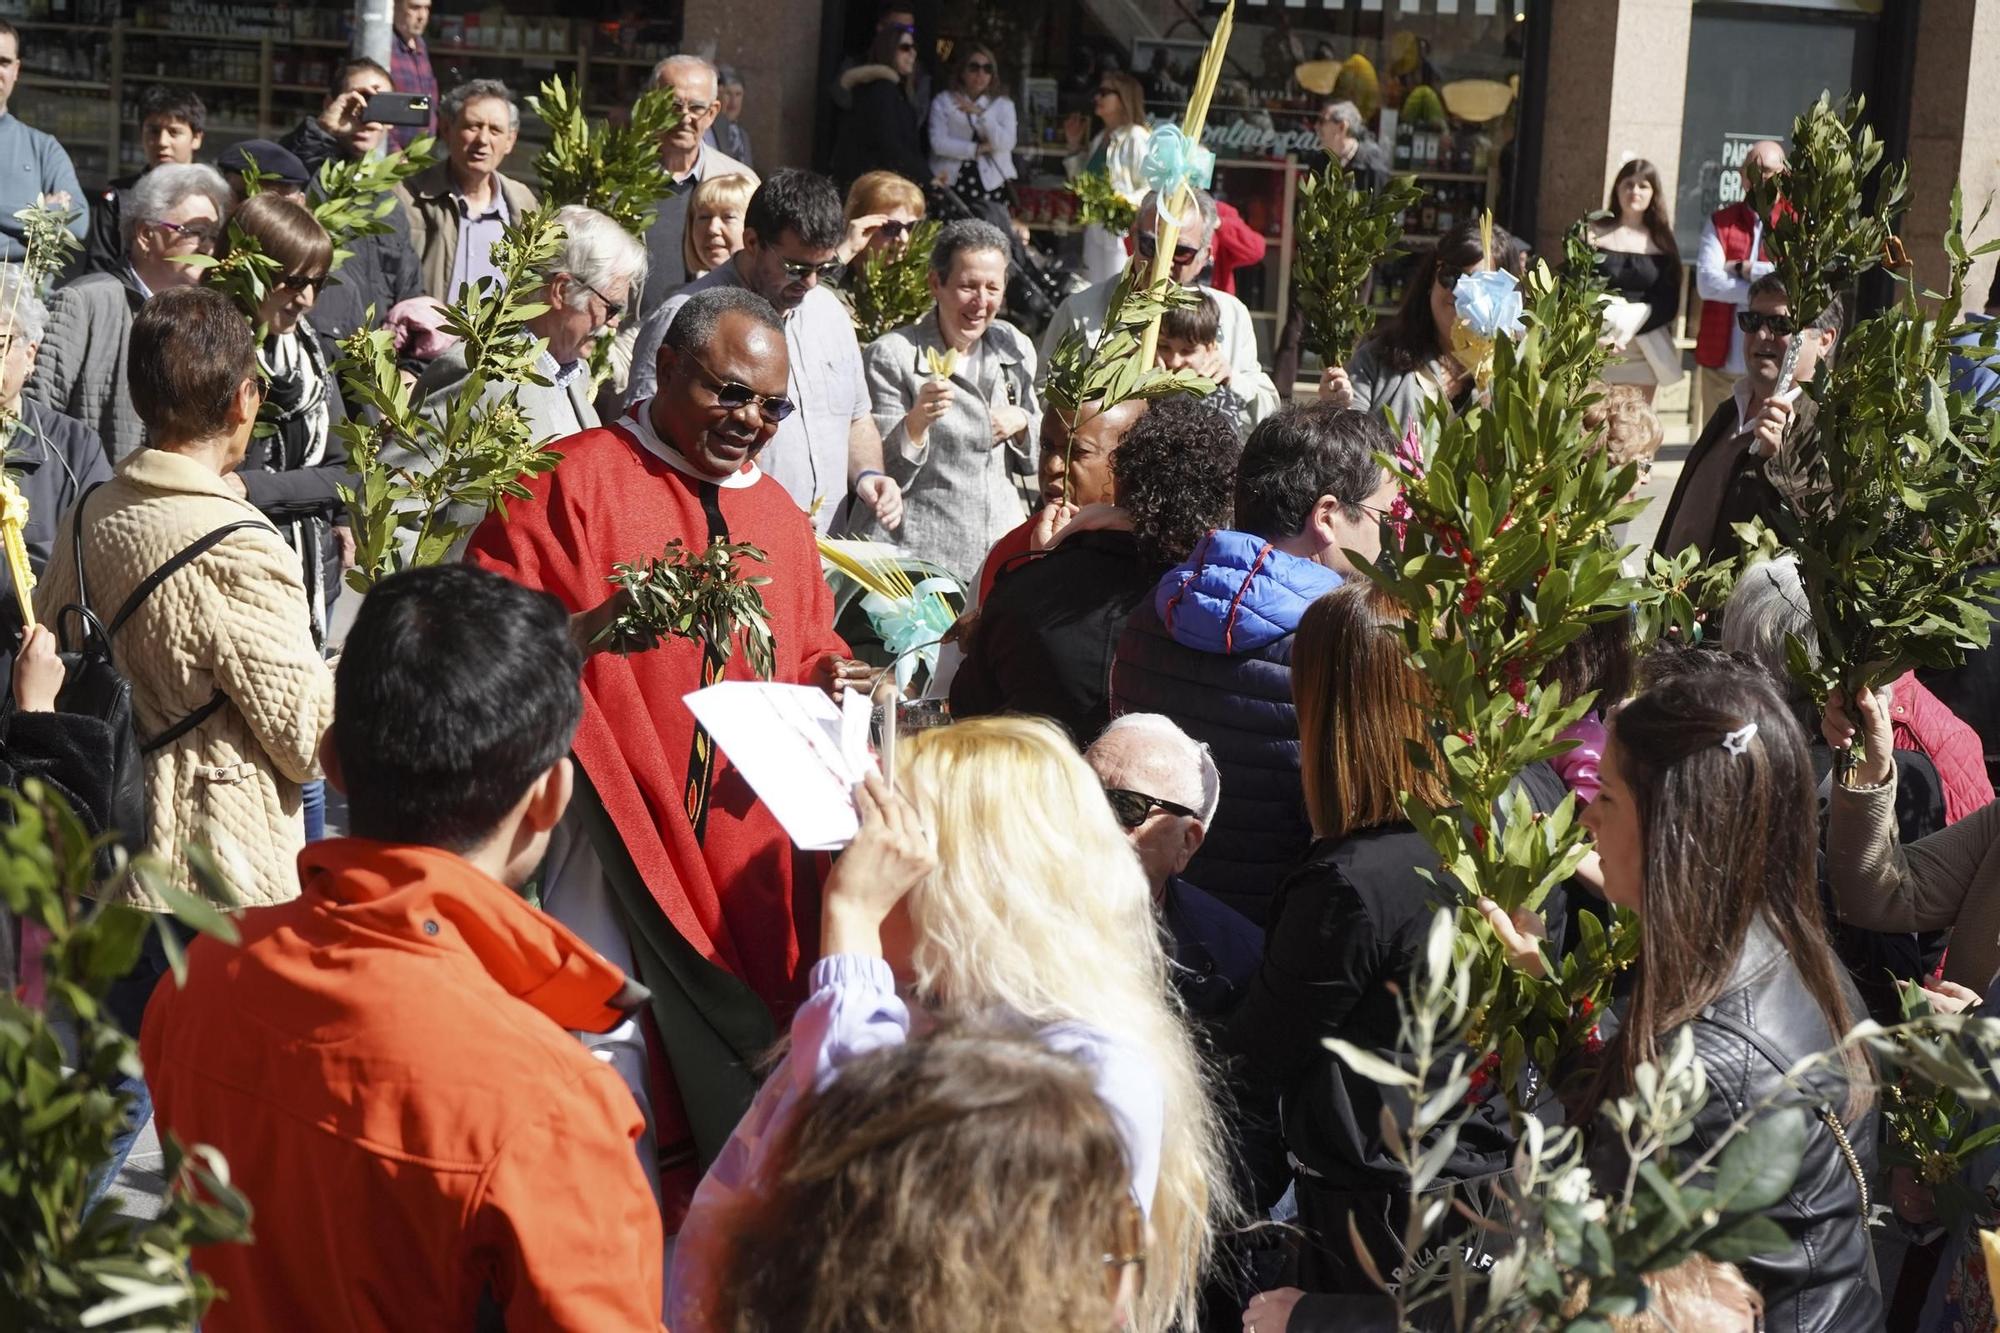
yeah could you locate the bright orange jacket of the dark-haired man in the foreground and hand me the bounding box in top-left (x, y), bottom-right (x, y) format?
top-left (140, 839), bottom-right (660, 1333)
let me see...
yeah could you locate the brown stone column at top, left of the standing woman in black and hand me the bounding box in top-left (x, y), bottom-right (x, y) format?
top-left (680, 0), bottom-right (826, 176)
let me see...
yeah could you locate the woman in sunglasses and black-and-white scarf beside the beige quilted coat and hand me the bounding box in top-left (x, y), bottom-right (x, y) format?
top-left (219, 192), bottom-right (354, 642)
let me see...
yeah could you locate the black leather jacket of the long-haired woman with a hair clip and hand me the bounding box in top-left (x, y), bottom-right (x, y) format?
top-left (1680, 923), bottom-right (1882, 1333)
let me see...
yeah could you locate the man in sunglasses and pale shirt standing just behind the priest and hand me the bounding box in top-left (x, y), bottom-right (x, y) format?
top-left (624, 168), bottom-right (902, 532)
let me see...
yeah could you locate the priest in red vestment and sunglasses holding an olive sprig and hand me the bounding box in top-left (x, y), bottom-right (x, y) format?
top-left (468, 288), bottom-right (870, 1233)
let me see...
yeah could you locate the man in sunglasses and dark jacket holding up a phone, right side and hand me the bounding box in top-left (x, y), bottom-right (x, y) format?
top-left (1654, 274), bottom-right (1842, 560)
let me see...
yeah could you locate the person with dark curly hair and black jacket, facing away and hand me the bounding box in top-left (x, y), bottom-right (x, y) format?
top-left (952, 398), bottom-right (1242, 745)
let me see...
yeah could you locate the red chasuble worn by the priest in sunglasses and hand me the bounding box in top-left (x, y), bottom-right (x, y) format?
top-left (468, 420), bottom-right (848, 1012)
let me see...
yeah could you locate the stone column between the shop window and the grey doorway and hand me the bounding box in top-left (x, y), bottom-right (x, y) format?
top-left (1534, 0), bottom-right (1694, 256)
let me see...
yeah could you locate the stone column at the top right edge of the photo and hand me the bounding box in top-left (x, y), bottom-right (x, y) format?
top-left (1902, 0), bottom-right (2000, 310)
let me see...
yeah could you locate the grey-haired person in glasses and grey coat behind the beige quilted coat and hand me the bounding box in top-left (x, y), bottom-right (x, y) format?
top-left (22, 162), bottom-right (234, 462)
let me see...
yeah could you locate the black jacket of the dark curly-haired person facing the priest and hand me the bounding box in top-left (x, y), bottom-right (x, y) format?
top-left (952, 530), bottom-right (1166, 747)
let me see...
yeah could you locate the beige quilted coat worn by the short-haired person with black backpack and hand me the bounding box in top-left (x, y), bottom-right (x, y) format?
top-left (34, 448), bottom-right (334, 911)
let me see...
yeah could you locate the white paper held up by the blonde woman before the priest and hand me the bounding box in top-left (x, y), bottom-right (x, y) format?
top-left (686, 681), bottom-right (874, 851)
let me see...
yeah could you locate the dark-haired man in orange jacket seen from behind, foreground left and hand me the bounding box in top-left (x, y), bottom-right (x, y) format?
top-left (140, 564), bottom-right (662, 1333)
